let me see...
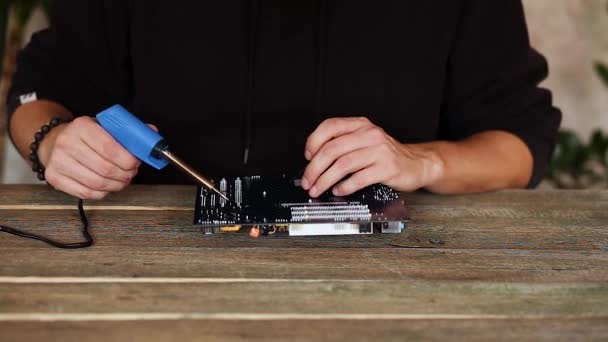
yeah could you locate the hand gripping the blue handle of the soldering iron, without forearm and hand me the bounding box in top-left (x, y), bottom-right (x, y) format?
top-left (38, 116), bottom-right (141, 199)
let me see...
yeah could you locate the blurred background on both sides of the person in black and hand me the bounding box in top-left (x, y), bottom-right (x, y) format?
top-left (0, 0), bottom-right (608, 188)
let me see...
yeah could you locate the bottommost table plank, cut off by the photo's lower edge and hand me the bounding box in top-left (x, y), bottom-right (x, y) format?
top-left (0, 318), bottom-right (608, 342)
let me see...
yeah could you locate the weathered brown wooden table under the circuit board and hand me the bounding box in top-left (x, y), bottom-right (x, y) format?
top-left (0, 186), bottom-right (608, 341)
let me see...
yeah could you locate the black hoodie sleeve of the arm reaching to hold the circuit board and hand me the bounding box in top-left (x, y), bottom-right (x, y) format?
top-left (442, 0), bottom-right (561, 188)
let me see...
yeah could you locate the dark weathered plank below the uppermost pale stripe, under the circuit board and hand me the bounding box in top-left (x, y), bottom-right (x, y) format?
top-left (0, 208), bottom-right (608, 251)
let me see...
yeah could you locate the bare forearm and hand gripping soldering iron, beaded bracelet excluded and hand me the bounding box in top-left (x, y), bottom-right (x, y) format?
top-left (10, 101), bottom-right (140, 199)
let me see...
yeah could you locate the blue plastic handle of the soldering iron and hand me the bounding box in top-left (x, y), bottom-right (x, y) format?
top-left (96, 105), bottom-right (169, 170)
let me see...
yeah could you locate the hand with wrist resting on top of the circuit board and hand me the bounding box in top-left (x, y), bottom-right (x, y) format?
top-left (302, 117), bottom-right (442, 197)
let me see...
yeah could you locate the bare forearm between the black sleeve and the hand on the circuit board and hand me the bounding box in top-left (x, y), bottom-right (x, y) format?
top-left (418, 131), bottom-right (533, 194)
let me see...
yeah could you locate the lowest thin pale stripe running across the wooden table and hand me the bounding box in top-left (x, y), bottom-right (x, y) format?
top-left (0, 312), bottom-right (605, 322)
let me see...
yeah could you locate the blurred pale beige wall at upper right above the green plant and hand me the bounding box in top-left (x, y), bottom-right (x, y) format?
top-left (524, 0), bottom-right (608, 139)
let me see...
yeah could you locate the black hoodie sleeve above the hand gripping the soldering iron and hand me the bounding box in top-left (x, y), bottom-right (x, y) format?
top-left (7, 0), bottom-right (131, 123)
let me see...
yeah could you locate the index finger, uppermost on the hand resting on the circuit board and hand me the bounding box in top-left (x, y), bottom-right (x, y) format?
top-left (304, 116), bottom-right (372, 160)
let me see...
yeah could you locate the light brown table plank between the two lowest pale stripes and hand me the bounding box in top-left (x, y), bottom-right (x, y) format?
top-left (0, 280), bottom-right (608, 320)
